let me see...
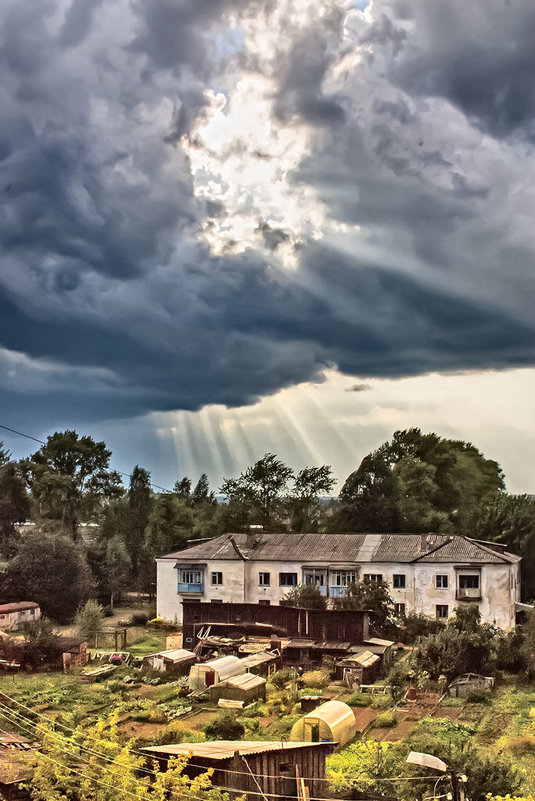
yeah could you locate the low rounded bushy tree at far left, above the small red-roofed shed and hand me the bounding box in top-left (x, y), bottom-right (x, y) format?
top-left (0, 531), bottom-right (93, 623)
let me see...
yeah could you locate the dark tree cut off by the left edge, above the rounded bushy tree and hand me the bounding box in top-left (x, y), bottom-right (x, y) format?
top-left (0, 442), bottom-right (30, 556)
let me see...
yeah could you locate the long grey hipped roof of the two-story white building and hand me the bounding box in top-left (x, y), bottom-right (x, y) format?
top-left (160, 531), bottom-right (520, 569)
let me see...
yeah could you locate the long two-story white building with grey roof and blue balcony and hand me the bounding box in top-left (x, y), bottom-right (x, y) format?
top-left (157, 530), bottom-right (520, 629)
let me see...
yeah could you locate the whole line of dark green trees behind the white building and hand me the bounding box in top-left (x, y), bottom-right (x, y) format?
top-left (0, 428), bottom-right (535, 620)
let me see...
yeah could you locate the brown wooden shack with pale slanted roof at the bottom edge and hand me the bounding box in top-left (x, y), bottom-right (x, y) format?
top-left (141, 740), bottom-right (333, 799)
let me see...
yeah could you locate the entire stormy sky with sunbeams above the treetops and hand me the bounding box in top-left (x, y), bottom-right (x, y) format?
top-left (0, 0), bottom-right (535, 492)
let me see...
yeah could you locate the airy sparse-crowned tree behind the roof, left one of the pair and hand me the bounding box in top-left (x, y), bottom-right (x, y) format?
top-left (220, 453), bottom-right (293, 527)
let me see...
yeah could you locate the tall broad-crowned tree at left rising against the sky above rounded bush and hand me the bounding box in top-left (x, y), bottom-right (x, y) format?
top-left (20, 431), bottom-right (123, 539)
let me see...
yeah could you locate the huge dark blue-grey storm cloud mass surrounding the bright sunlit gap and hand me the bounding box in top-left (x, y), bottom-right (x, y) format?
top-left (0, 0), bottom-right (535, 426)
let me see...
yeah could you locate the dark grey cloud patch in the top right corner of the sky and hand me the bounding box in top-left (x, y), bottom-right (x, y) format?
top-left (384, 0), bottom-right (535, 139)
